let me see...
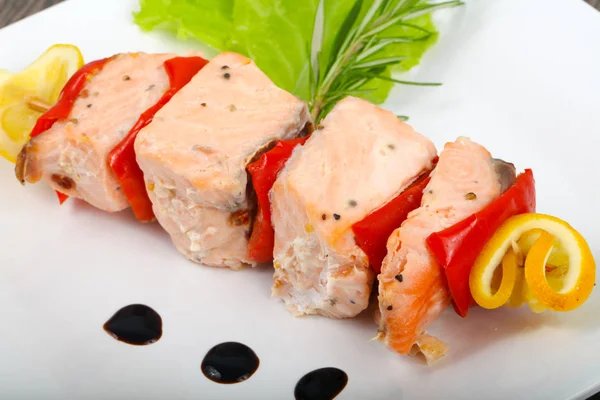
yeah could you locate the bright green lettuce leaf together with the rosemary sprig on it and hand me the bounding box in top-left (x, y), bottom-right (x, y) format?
top-left (134, 0), bottom-right (462, 122)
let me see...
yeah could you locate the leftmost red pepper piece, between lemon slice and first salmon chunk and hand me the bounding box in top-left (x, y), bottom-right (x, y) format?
top-left (29, 58), bottom-right (111, 204)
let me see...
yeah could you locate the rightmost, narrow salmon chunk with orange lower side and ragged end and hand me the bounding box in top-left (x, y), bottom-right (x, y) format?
top-left (379, 137), bottom-right (515, 362)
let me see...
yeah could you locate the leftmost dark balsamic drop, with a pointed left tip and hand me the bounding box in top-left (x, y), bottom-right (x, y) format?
top-left (104, 304), bottom-right (162, 346)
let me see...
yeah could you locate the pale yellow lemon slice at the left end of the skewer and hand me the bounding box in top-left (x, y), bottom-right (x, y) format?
top-left (0, 44), bottom-right (83, 162)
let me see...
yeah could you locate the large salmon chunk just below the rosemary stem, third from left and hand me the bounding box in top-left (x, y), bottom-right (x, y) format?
top-left (270, 97), bottom-right (436, 318)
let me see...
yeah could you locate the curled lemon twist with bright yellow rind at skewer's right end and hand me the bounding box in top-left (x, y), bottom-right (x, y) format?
top-left (469, 213), bottom-right (596, 312)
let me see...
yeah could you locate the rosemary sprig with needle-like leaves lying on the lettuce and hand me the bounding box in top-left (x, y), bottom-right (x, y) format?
top-left (309, 0), bottom-right (463, 123)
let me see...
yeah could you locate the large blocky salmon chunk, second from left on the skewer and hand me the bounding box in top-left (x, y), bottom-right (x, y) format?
top-left (135, 53), bottom-right (310, 269)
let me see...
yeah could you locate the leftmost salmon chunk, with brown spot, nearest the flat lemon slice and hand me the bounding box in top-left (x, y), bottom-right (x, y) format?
top-left (17, 53), bottom-right (175, 212)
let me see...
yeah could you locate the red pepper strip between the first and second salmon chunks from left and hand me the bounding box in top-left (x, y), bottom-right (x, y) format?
top-left (108, 57), bottom-right (208, 222)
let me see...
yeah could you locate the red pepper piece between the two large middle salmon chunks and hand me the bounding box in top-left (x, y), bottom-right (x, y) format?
top-left (248, 136), bottom-right (308, 262)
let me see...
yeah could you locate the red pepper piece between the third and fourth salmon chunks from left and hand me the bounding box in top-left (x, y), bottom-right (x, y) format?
top-left (352, 171), bottom-right (430, 273)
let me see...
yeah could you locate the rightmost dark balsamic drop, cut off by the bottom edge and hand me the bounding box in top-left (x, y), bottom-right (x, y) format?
top-left (294, 368), bottom-right (348, 400)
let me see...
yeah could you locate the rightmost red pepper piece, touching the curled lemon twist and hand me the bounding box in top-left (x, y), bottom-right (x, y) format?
top-left (426, 169), bottom-right (536, 318)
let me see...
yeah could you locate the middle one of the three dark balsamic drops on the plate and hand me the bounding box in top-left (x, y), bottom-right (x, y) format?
top-left (200, 342), bottom-right (260, 383)
